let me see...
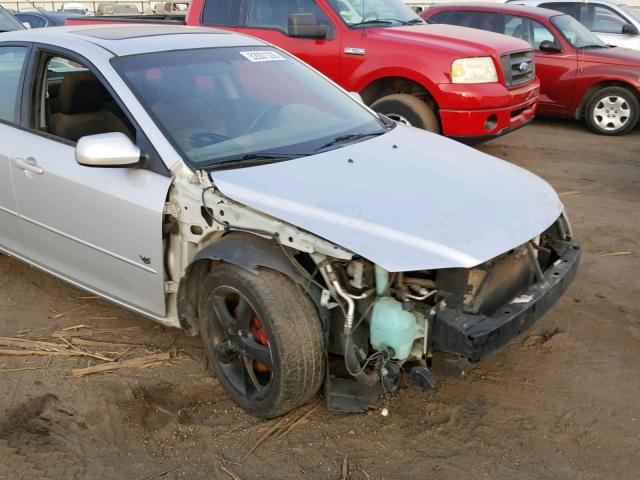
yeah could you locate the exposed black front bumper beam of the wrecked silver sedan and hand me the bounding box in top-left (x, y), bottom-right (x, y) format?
top-left (433, 246), bottom-right (580, 362)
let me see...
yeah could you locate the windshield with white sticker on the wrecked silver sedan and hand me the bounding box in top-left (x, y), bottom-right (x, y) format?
top-left (112, 47), bottom-right (385, 168)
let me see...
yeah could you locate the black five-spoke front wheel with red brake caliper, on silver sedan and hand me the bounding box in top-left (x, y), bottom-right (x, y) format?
top-left (198, 264), bottom-right (325, 418)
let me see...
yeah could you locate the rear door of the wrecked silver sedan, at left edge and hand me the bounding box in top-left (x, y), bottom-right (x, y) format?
top-left (0, 43), bottom-right (29, 256)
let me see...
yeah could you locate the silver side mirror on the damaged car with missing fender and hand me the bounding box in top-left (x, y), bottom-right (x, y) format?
top-left (76, 132), bottom-right (140, 167)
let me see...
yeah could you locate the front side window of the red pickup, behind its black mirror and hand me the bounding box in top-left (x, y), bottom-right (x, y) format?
top-left (248, 0), bottom-right (331, 33)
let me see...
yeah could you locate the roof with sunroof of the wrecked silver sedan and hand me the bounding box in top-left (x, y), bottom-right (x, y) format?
top-left (0, 23), bottom-right (267, 56)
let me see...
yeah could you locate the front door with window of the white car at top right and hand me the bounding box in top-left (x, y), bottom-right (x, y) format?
top-left (582, 3), bottom-right (637, 48)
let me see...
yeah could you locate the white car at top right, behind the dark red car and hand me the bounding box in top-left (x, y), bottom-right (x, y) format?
top-left (506, 0), bottom-right (640, 50)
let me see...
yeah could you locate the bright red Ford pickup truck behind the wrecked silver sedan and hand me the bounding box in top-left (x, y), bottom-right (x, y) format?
top-left (67, 0), bottom-right (540, 141)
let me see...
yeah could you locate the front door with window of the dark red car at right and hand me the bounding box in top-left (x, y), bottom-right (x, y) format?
top-left (504, 15), bottom-right (578, 115)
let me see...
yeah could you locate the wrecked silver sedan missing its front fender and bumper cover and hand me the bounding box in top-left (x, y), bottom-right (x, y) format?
top-left (0, 25), bottom-right (580, 417)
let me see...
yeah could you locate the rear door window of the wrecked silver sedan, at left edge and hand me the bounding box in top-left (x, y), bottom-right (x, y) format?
top-left (0, 47), bottom-right (27, 123)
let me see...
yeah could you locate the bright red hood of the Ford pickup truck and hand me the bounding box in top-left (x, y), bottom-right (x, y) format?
top-left (367, 24), bottom-right (531, 57)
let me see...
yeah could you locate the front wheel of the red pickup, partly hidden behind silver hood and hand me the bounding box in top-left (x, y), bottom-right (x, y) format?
top-left (371, 93), bottom-right (440, 133)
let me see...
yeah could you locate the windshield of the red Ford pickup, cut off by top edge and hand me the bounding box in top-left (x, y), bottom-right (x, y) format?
top-left (328, 0), bottom-right (424, 27)
